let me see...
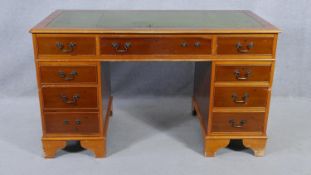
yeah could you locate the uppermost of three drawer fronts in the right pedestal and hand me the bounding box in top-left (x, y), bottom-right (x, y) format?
top-left (215, 65), bottom-right (271, 82)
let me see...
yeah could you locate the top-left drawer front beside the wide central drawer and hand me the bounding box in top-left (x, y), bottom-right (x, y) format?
top-left (37, 37), bottom-right (96, 55)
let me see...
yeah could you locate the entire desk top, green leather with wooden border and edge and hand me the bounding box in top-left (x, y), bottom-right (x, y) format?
top-left (31, 10), bottom-right (279, 33)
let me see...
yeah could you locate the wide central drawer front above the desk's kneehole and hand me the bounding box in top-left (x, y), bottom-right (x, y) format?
top-left (100, 37), bottom-right (212, 55)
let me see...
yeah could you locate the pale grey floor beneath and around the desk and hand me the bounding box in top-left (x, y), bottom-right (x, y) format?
top-left (0, 97), bottom-right (311, 175)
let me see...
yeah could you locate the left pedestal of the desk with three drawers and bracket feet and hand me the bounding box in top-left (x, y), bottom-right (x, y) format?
top-left (36, 55), bottom-right (112, 158)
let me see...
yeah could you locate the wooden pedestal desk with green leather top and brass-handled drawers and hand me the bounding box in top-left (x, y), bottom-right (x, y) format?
top-left (31, 10), bottom-right (279, 158)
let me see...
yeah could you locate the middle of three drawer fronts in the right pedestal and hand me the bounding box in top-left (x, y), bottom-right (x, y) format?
top-left (214, 87), bottom-right (268, 107)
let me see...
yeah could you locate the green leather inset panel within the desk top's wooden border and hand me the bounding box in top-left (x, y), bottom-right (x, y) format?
top-left (46, 10), bottom-right (264, 29)
